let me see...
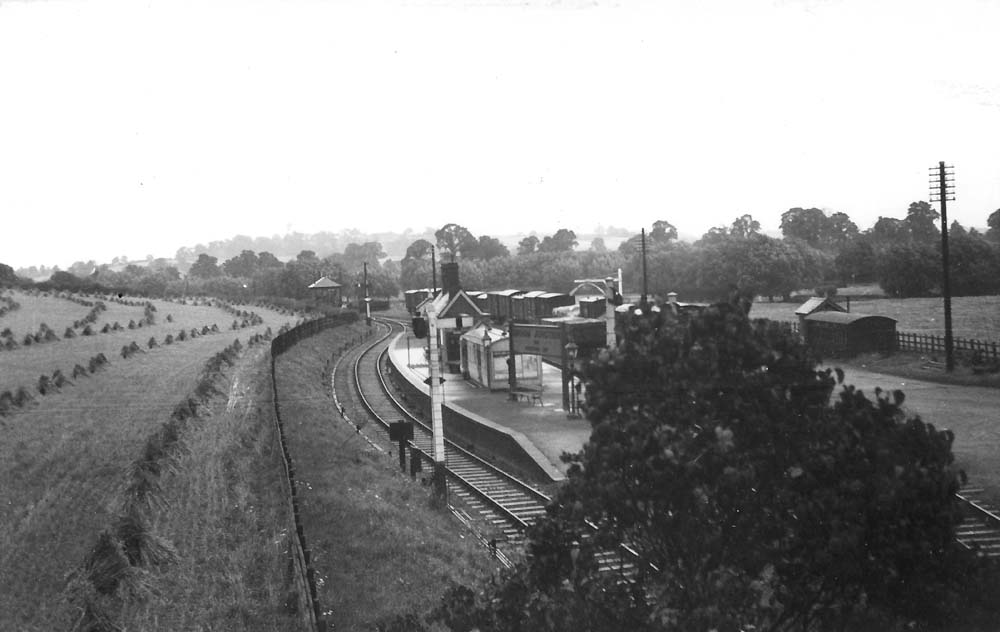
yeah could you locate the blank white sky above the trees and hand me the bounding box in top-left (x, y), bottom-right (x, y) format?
top-left (0, 0), bottom-right (1000, 268)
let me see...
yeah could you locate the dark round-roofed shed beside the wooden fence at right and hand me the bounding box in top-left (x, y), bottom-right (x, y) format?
top-left (803, 311), bottom-right (896, 357)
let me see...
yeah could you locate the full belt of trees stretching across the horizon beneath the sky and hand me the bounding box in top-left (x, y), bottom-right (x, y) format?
top-left (7, 201), bottom-right (1000, 300)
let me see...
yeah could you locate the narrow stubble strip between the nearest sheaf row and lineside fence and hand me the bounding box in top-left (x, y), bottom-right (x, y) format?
top-left (122, 345), bottom-right (305, 632)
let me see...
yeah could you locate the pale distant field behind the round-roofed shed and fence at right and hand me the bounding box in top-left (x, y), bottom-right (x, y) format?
top-left (750, 296), bottom-right (1000, 342)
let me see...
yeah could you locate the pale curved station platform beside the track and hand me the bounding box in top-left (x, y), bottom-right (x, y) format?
top-left (389, 333), bottom-right (591, 482)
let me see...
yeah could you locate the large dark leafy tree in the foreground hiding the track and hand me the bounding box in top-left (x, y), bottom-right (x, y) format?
top-left (438, 304), bottom-right (975, 632)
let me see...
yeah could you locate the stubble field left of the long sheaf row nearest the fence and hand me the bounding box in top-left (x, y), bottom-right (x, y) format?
top-left (0, 294), bottom-right (288, 630)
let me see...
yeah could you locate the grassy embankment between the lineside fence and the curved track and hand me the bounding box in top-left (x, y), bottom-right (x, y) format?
top-left (277, 324), bottom-right (496, 630)
